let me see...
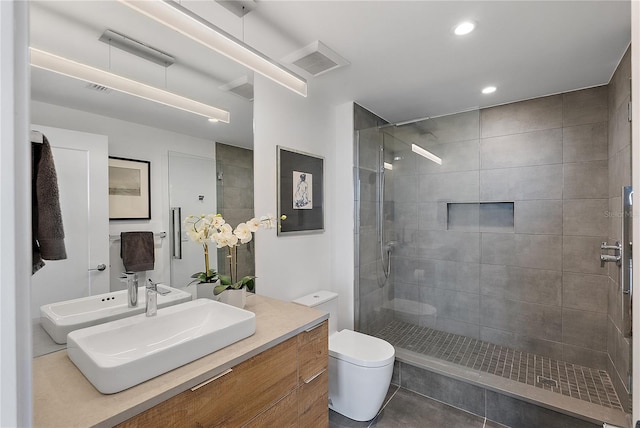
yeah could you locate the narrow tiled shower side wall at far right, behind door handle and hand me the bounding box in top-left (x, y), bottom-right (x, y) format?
top-left (608, 48), bottom-right (631, 409)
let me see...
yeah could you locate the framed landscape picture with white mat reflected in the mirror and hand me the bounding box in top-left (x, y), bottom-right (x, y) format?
top-left (109, 156), bottom-right (151, 220)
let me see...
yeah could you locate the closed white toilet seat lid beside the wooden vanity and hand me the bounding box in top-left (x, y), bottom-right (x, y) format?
top-left (329, 330), bottom-right (395, 367)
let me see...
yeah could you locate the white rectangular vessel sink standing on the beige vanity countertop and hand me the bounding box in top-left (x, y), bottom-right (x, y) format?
top-left (67, 299), bottom-right (256, 394)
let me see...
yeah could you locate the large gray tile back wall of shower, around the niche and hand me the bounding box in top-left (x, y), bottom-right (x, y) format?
top-left (385, 86), bottom-right (624, 369)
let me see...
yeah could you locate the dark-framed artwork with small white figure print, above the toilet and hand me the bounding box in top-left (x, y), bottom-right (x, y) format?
top-left (277, 146), bottom-right (324, 235)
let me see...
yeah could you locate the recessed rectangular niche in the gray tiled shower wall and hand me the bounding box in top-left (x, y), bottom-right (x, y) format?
top-left (447, 202), bottom-right (513, 233)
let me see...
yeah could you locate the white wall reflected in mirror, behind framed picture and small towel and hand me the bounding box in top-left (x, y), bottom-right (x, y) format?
top-left (31, 101), bottom-right (216, 290)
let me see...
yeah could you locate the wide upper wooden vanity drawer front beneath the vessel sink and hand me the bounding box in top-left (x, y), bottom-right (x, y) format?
top-left (119, 338), bottom-right (297, 427)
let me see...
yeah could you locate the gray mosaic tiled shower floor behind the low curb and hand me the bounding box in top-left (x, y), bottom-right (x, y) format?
top-left (376, 321), bottom-right (622, 410)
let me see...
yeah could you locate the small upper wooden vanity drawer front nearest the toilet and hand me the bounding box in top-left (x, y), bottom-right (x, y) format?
top-left (298, 321), bottom-right (329, 383)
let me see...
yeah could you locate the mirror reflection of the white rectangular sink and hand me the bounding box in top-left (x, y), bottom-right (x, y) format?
top-left (40, 284), bottom-right (192, 344)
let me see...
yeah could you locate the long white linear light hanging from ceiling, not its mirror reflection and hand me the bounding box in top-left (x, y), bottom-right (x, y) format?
top-left (119, 0), bottom-right (307, 97)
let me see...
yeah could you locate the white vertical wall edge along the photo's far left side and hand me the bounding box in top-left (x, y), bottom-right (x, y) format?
top-left (0, 1), bottom-right (32, 427)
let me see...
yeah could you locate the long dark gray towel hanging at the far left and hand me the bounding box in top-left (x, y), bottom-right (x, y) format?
top-left (31, 135), bottom-right (67, 274)
